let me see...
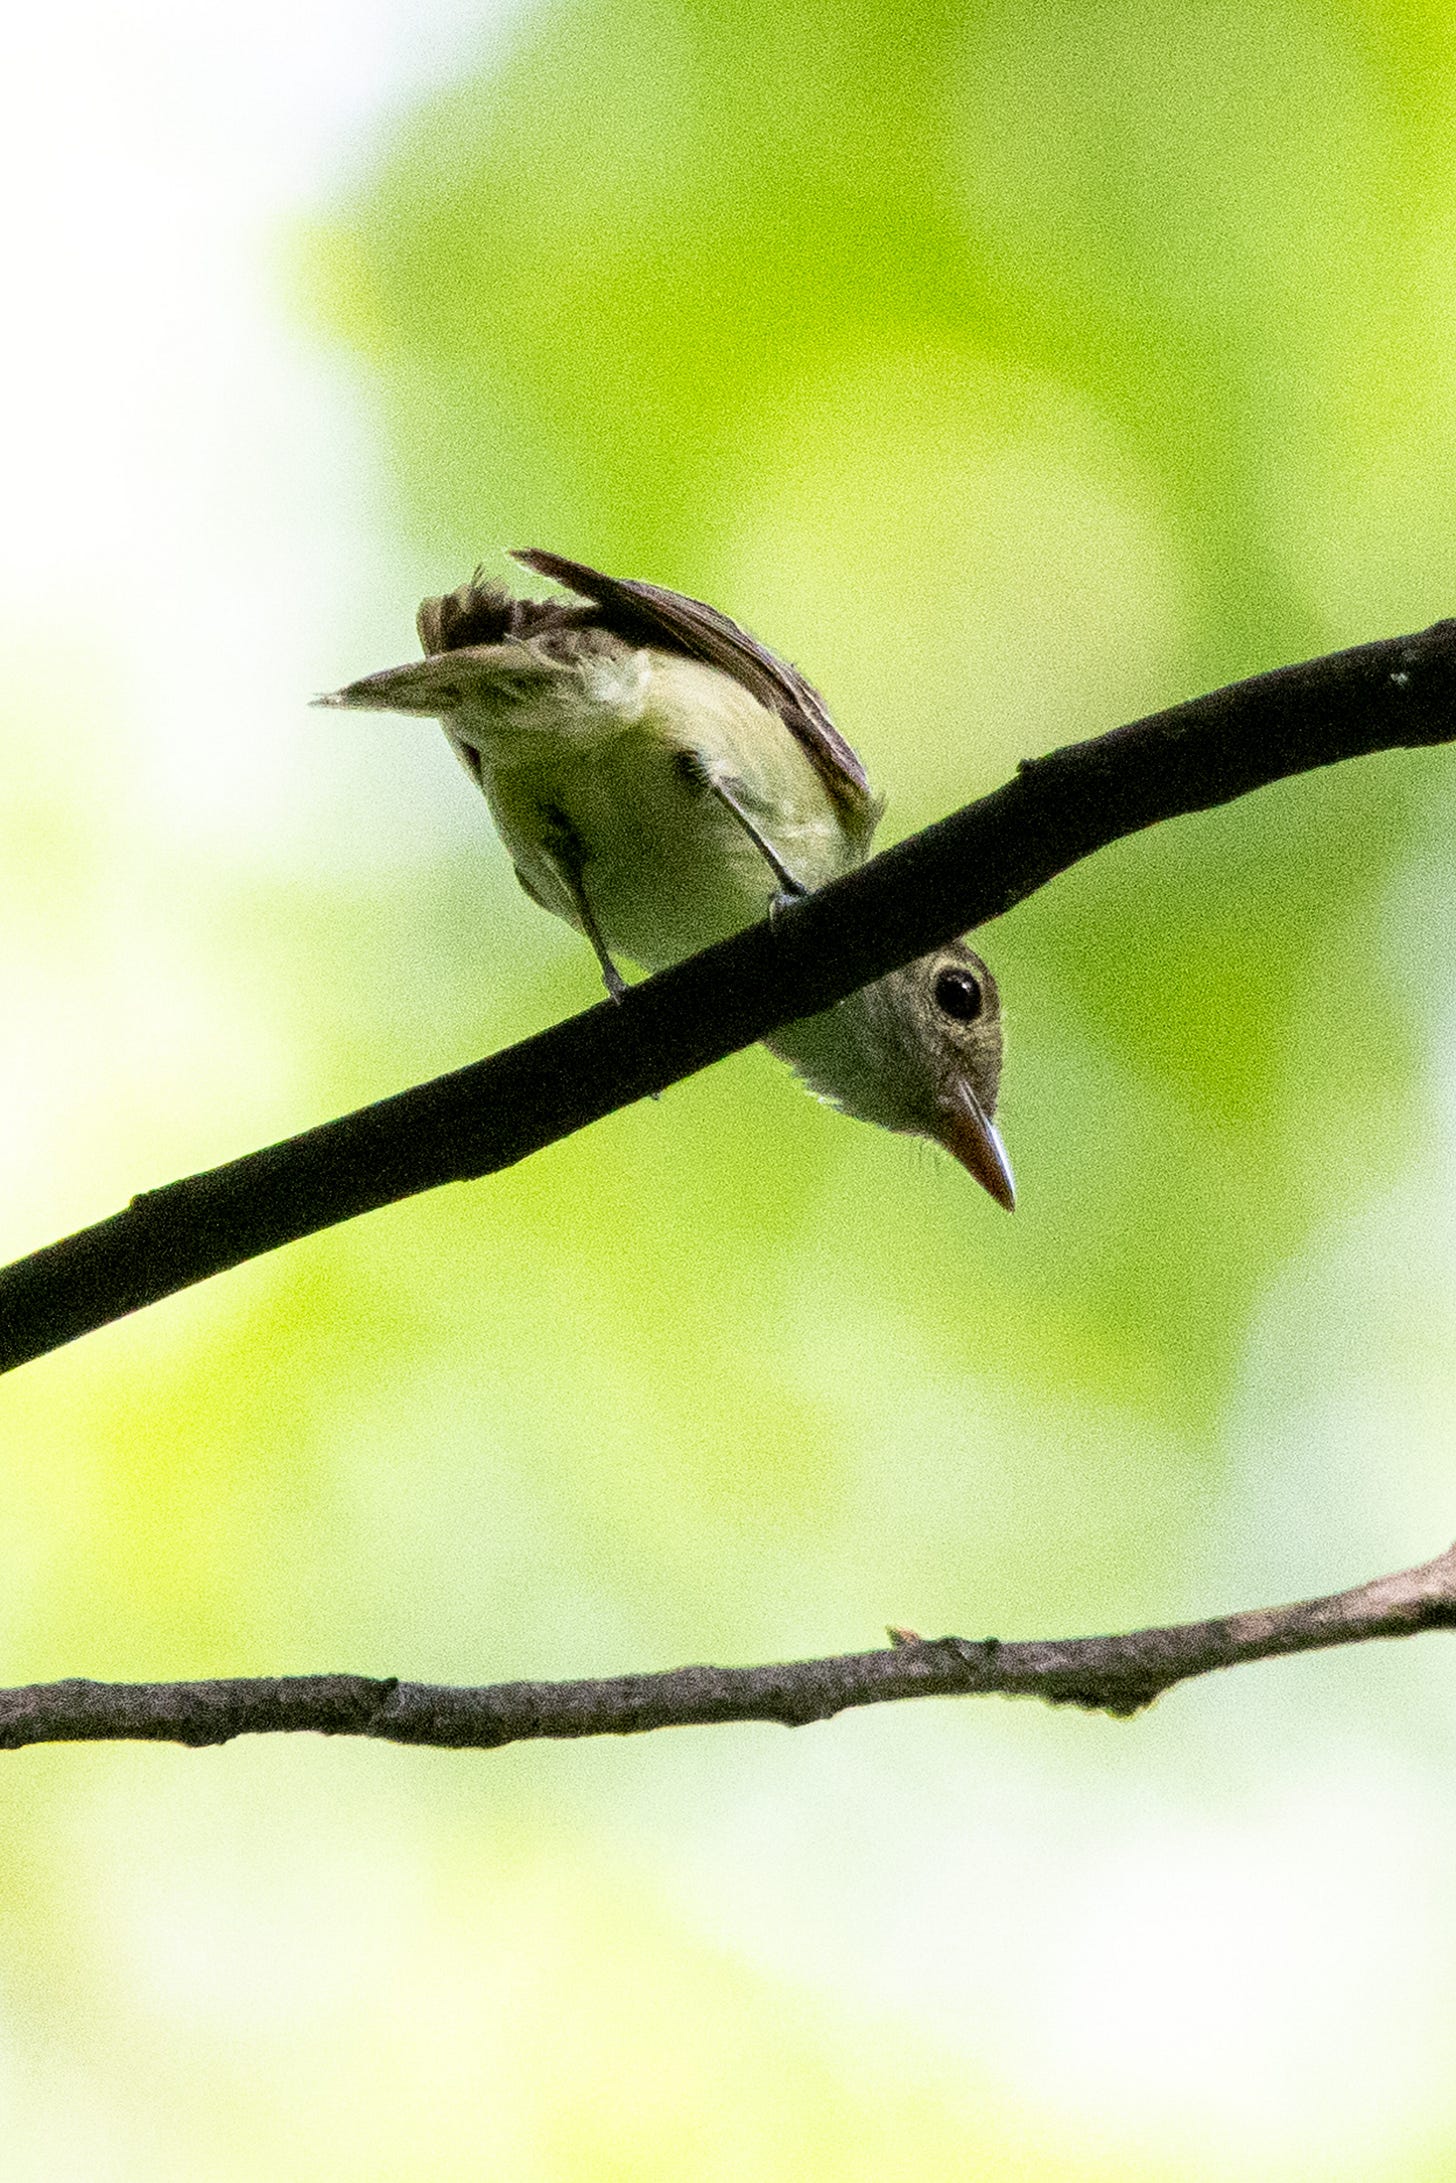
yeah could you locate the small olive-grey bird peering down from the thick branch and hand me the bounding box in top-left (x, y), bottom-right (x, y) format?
top-left (317, 552), bottom-right (1015, 1212)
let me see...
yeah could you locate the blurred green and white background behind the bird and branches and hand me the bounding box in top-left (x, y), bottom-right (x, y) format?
top-left (0, 0), bottom-right (1456, 2183)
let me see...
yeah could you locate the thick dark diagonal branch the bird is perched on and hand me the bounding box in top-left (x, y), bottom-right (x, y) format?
top-left (0, 622), bottom-right (1456, 1371)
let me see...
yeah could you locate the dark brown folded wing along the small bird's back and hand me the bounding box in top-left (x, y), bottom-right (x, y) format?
top-left (513, 550), bottom-right (880, 825)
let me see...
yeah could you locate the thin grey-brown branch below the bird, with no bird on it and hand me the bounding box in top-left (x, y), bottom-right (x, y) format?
top-left (0, 1546), bottom-right (1456, 1751)
